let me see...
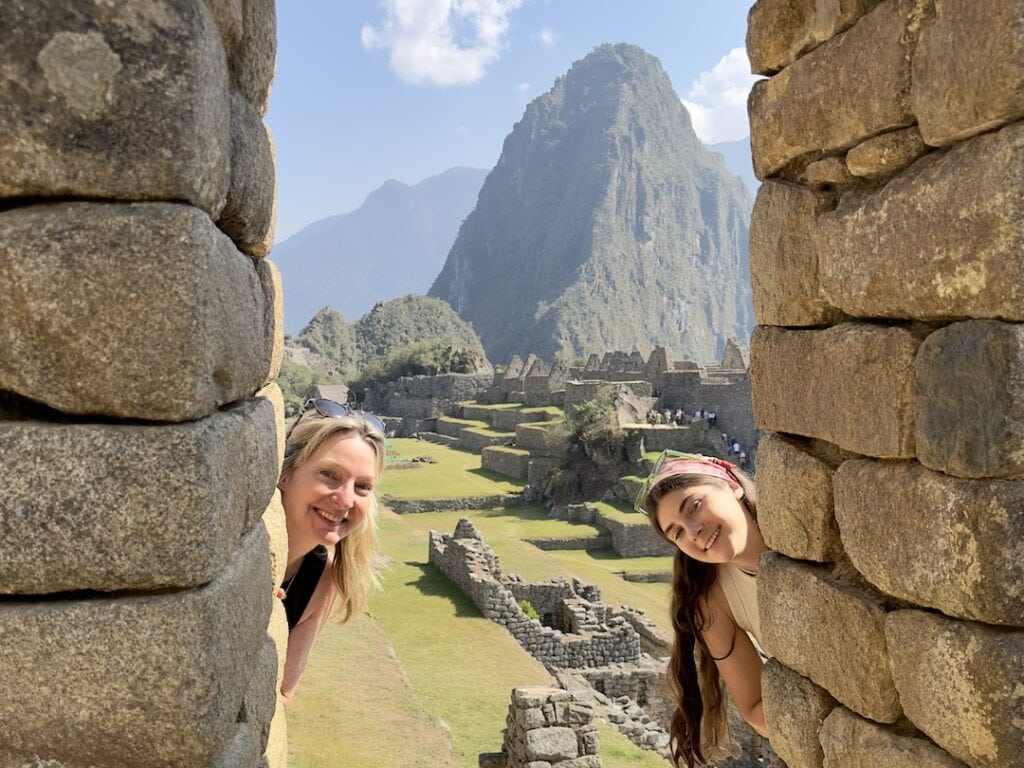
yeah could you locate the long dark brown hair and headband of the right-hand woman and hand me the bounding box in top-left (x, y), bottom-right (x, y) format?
top-left (643, 469), bottom-right (757, 768)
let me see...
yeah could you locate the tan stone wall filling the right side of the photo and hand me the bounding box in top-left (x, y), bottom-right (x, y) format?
top-left (748, 0), bottom-right (1024, 768)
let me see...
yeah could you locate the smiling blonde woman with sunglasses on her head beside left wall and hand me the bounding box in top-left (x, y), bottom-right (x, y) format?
top-left (278, 399), bottom-right (384, 703)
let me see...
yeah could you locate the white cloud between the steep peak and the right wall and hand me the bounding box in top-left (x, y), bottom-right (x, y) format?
top-left (682, 48), bottom-right (759, 144)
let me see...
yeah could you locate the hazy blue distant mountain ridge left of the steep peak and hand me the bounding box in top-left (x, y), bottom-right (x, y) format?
top-left (272, 168), bottom-right (487, 334)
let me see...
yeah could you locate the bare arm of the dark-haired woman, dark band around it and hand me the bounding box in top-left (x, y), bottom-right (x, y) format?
top-left (702, 583), bottom-right (768, 737)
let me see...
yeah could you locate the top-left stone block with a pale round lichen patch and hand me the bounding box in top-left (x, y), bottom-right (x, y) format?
top-left (0, 0), bottom-right (229, 218)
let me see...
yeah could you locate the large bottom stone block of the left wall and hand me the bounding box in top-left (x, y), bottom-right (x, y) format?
top-left (0, 527), bottom-right (272, 768)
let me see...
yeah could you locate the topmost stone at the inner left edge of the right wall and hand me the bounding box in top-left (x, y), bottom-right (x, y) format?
top-left (746, 0), bottom-right (880, 75)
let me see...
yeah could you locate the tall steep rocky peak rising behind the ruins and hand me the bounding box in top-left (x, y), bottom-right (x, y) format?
top-left (430, 44), bottom-right (754, 361)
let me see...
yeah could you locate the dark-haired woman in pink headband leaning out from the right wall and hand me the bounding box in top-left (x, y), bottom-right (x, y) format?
top-left (636, 451), bottom-right (768, 768)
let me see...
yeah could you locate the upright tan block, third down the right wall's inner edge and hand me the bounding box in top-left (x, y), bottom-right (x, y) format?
top-left (750, 181), bottom-right (839, 326)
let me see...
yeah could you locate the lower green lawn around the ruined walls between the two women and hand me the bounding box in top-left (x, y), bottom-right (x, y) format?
top-left (288, 505), bottom-right (668, 768)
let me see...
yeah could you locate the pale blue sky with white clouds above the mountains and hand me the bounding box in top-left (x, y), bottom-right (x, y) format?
top-left (266, 0), bottom-right (753, 242)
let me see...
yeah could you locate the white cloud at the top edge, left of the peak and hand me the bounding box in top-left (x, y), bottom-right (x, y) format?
top-left (360, 0), bottom-right (522, 85)
